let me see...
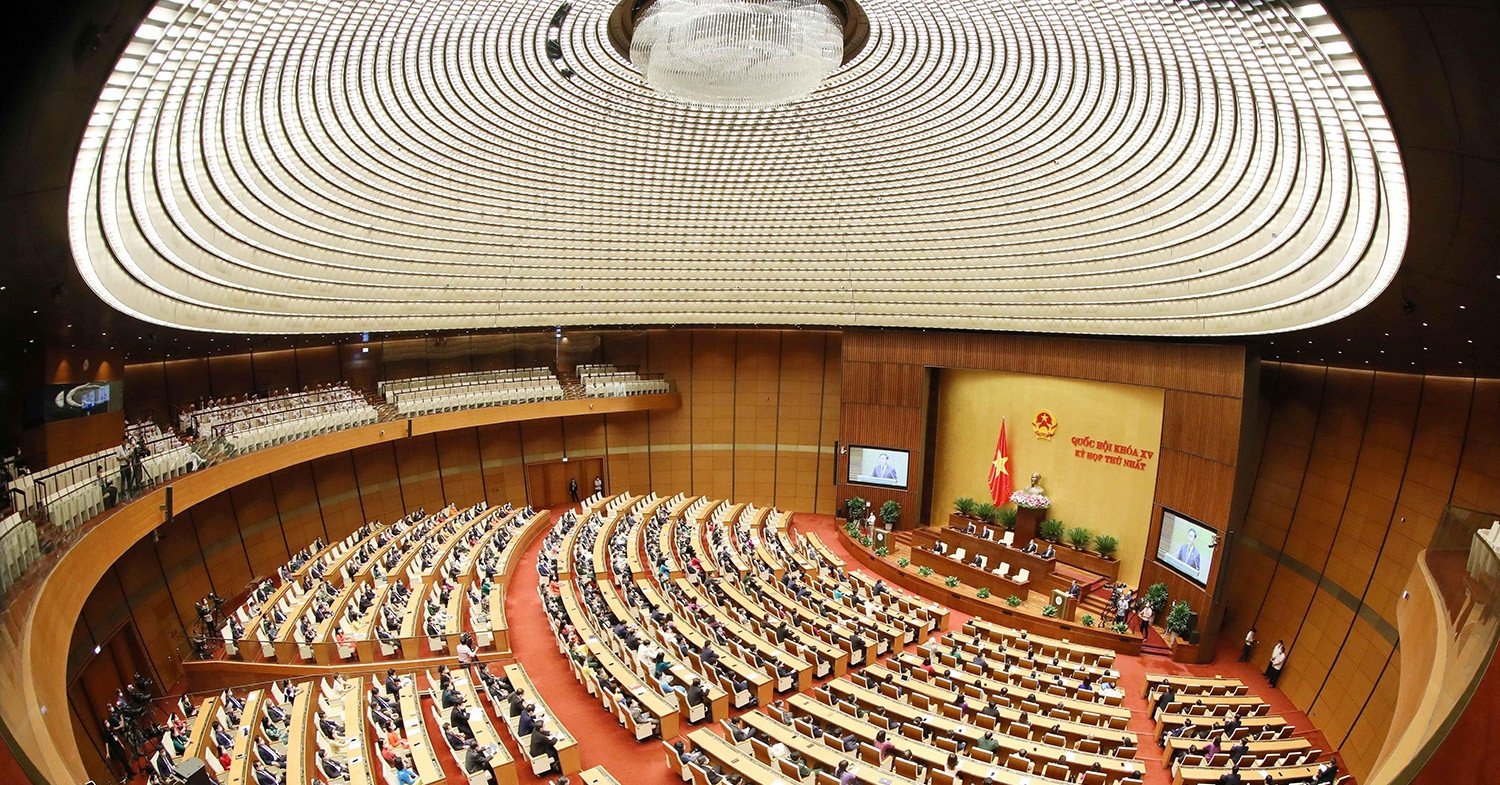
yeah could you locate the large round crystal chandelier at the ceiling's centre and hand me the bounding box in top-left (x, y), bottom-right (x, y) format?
top-left (630, 0), bottom-right (845, 107)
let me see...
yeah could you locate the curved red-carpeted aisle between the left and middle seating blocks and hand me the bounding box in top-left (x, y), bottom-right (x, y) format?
top-left (506, 507), bottom-right (683, 785)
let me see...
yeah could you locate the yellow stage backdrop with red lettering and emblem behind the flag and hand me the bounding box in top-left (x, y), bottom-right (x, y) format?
top-left (933, 369), bottom-right (1166, 584)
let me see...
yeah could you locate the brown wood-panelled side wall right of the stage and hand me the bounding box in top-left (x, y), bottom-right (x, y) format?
top-left (1230, 363), bottom-right (1500, 776)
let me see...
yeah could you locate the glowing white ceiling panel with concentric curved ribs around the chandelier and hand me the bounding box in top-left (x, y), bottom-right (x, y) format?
top-left (69, 0), bottom-right (1407, 335)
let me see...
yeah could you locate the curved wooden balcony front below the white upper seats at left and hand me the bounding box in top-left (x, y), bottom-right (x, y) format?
top-left (0, 393), bottom-right (681, 785)
